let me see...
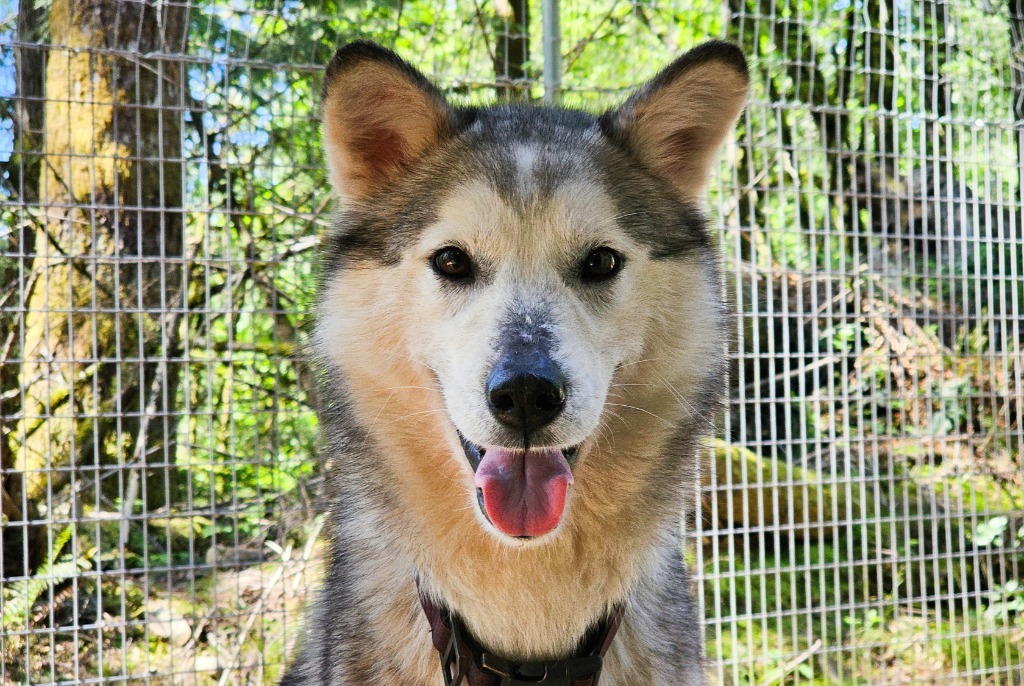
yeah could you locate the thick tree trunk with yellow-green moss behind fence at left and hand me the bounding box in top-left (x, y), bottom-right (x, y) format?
top-left (4, 0), bottom-right (187, 577)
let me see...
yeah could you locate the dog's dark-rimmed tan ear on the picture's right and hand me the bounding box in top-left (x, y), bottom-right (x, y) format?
top-left (601, 41), bottom-right (750, 202)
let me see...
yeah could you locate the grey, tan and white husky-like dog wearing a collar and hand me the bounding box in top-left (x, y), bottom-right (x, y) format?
top-left (282, 41), bottom-right (749, 686)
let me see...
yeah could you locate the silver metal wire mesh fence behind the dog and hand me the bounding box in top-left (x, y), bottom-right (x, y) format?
top-left (0, 0), bottom-right (1024, 685)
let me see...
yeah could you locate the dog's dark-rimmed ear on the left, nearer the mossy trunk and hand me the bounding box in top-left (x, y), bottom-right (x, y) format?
top-left (323, 41), bottom-right (454, 201)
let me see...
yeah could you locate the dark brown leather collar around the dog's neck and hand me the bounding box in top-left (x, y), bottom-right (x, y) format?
top-left (417, 580), bottom-right (625, 686)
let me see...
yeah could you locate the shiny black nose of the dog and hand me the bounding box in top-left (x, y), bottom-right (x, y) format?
top-left (487, 355), bottom-right (565, 436)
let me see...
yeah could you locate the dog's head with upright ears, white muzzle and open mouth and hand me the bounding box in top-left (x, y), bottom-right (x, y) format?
top-left (317, 42), bottom-right (748, 540)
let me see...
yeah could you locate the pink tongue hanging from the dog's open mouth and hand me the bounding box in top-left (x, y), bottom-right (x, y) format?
top-left (474, 447), bottom-right (572, 537)
